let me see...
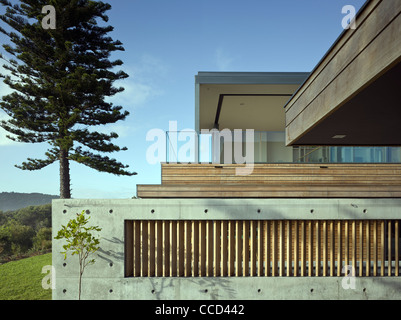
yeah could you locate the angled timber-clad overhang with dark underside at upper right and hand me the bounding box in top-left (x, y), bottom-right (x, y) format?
top-left (285, 0), bottom-right (401, 146)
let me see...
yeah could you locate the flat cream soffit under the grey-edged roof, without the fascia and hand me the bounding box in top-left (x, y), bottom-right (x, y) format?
top-left (199, 83), bottom-right (301, 131)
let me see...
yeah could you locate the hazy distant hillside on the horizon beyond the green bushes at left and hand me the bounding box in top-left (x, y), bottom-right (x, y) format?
top-left (0, 192), bottom-right (59, 212)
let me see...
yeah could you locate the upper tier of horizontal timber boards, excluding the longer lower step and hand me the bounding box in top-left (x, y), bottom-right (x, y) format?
top-left (162, 163), bottom-right (401, 186)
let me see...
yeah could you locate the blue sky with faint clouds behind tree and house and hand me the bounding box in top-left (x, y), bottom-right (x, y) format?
top-left (0, 0), bottom-right (364, 198)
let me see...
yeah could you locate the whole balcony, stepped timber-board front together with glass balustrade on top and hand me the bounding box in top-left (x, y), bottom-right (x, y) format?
top-left (137, 130), bottom-right (401, 199)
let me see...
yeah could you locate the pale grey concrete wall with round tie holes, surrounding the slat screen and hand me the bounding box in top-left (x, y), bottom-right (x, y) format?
top-left (52, 199), bottom-right (401, 300)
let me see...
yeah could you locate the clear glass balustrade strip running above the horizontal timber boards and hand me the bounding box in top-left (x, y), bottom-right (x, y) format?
top-left (165, 130), bottom-right (401, 164)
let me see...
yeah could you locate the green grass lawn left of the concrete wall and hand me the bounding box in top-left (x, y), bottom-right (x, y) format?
top-left (0, 253), bottom-right (52, 300)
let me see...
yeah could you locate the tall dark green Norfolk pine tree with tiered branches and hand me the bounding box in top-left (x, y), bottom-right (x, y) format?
top-left (0, 0), bottom-right (136, 199)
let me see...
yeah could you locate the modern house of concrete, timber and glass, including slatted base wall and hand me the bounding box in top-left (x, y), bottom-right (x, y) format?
top-left (52, 0), bottom-right (401, 300)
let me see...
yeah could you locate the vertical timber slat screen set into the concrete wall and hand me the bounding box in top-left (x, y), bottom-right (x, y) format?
top-left (125, 220), bottom-right (400, 277)
